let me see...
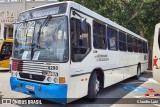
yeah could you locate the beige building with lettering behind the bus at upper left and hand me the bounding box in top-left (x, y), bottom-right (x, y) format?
top-left (0, 0), bottom-right (58, 39)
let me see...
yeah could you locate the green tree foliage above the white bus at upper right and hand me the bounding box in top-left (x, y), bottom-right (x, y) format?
top-left (60, 0), bottom-right (160, 46)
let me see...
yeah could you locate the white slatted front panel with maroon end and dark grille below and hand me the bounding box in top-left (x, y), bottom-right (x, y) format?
top-left (12, 60), bottom-right (48, 81)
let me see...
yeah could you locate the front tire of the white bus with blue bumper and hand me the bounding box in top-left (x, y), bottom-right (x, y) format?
top-left (88, 72), bottom-right (99, 101)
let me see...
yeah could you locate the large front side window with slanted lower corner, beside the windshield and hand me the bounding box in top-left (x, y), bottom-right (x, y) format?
top-left (70, 18), bottom-right (91, 62)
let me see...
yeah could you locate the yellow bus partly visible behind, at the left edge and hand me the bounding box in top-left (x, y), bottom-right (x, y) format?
top-left (0, 39), bottom-right (13, 71)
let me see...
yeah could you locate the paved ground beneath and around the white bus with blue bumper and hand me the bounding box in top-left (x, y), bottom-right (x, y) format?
top-left (0, 71), bottom-right (160, 107)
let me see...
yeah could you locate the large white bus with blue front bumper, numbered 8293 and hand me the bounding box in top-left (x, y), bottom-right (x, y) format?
top-left (10, 1), bottom-right (148, 103)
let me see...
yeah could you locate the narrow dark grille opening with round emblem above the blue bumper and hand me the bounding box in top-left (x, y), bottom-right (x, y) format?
top-left (19, 73), bottom-right (45, 81)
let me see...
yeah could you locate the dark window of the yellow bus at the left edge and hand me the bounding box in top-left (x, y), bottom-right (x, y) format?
top-left (0, 42), bottom-right (12, 60)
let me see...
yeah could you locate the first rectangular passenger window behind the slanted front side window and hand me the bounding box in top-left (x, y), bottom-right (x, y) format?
top-left (93, 21), bottom-right (106, 49)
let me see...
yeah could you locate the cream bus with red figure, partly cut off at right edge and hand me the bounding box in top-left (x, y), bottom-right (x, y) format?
top-left (152, 23), bottom-right (160, 82)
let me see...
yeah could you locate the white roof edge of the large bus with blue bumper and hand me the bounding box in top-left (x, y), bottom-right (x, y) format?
top-left (21, 1), bottom-right (147, 42)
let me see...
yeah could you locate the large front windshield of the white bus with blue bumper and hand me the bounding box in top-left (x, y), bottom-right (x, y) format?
top-left (13, 16), bottom-right (68, 62)
